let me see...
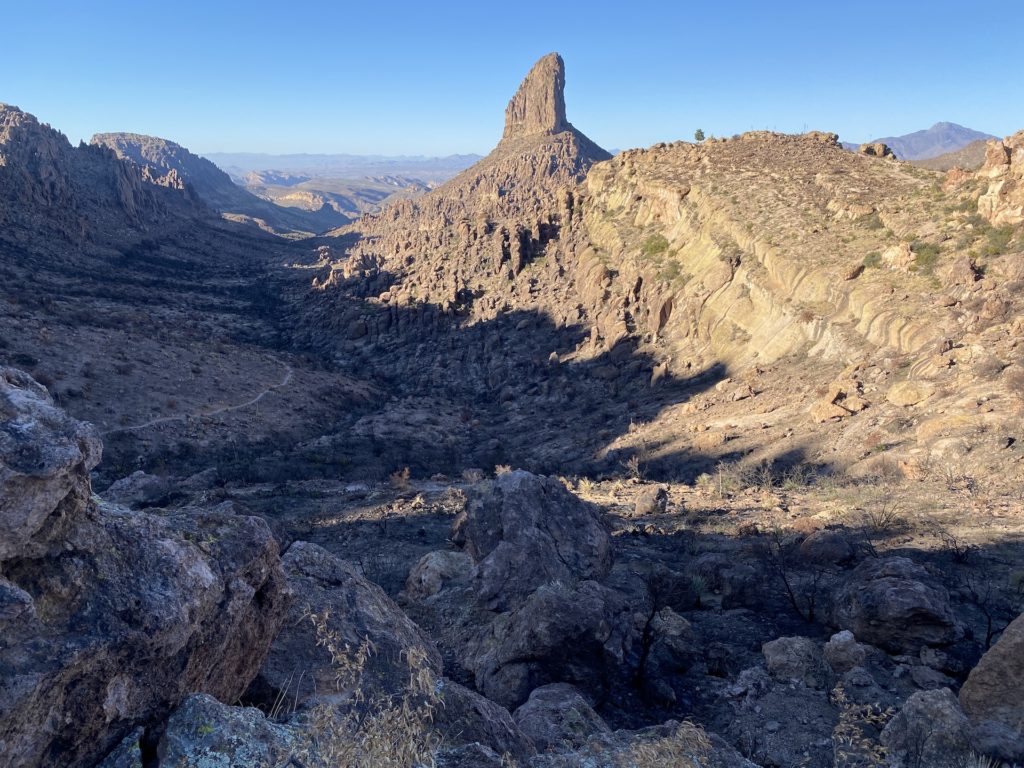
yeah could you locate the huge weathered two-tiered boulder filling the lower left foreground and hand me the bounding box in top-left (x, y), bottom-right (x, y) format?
top-left (0, 372), bottom-right (288, 768)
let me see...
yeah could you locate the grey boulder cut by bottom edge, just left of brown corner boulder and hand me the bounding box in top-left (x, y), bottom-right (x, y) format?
top-left (880, 688), bottom-right (971, 768)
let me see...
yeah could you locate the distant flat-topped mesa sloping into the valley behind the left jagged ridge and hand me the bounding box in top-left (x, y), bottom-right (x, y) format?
top-left (90, 133), bottom-right (349, 232)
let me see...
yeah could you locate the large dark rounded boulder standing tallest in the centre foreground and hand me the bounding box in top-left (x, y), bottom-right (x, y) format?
top-left (453, 470), bottom-right (612, 610)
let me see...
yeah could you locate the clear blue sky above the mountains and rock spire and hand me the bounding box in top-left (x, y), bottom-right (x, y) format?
top-left (0, 0), bottom-right (1024, 155)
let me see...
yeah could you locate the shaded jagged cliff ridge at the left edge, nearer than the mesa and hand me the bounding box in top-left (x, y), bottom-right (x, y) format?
top-left (0, 103), bottom-right (198, 243)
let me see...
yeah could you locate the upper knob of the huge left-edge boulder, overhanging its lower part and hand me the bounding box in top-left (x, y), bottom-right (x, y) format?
top-left (0, 368), bottom-right (102, 562)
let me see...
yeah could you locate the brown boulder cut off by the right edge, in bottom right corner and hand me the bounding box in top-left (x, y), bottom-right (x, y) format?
top-left (959, 614), bottom-right (1024, 760)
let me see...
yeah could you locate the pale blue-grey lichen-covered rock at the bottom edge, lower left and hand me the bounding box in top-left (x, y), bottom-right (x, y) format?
top-left (157, 693), bottom-right (302, 768)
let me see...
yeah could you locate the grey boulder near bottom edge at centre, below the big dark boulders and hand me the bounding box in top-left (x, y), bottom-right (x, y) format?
top-left (512, 683), bottom-right (611, 752)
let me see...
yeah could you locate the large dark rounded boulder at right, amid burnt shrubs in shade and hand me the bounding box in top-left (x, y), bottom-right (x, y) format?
top-left (831, 557), bottom-right (963, 653)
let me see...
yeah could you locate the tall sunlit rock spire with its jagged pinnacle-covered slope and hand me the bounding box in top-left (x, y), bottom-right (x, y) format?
top-left (311, 54), bottom-right (609, 319)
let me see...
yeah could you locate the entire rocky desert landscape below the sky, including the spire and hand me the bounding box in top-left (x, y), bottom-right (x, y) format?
top-left (0, 53), bottom-right (1024, 768)
